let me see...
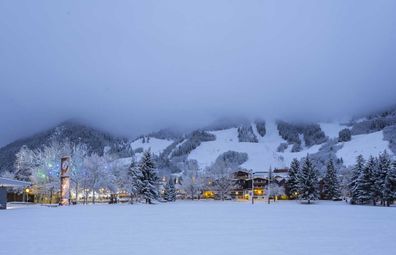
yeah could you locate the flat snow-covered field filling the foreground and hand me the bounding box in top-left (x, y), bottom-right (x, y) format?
top-left (0, 201), bottom-right (396, 255)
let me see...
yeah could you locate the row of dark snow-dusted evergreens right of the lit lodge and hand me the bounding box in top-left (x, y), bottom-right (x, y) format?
top-left (286, 151), bottom-right (396, 206)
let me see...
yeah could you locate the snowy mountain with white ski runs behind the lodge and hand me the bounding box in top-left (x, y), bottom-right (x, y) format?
top-left (131, 109), bottom-right (396, 172)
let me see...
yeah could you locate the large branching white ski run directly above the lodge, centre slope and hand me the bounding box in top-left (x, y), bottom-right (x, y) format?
top-left (188, 121), bottom-right (321, 172)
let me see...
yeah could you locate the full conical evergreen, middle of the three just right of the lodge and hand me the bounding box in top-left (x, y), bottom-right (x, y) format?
top-left (298, 155), bottom-right (319, 204)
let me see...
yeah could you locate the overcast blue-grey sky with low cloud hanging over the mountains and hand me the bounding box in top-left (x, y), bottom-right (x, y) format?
top-left (0, 0), bottom-right (396, 146)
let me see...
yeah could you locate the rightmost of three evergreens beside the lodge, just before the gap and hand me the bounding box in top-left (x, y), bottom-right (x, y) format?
top-left (322, 159), bottom-right (341, 200)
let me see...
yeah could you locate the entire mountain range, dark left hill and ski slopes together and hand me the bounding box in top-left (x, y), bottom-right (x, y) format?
top-left (0, 108), bottom-right (396, 173)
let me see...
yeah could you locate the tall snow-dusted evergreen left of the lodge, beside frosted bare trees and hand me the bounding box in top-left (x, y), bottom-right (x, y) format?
top-left (139, 151), bottom-right (159, 204)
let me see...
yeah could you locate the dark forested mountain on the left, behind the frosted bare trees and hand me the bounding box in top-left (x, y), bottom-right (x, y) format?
top-left (0, 121), bottom-right (127, 171)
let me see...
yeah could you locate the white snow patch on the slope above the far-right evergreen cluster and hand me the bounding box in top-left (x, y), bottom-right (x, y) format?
top-left (337, 131), bottom-right (391, 166)
